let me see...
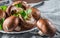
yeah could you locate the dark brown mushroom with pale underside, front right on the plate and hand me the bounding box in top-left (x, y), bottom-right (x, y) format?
top-left (21, 17), bottom-right (36, 30)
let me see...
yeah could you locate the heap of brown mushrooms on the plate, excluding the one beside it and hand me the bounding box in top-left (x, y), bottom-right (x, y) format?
top-left (0, 1), bottom-right (40, 32)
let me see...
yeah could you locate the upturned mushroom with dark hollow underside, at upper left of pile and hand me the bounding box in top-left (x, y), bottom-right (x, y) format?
top-left (6, 5), bottom-right (22, 16)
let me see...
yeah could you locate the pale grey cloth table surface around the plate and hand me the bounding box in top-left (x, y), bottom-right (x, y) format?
top-left (0, 0), bottom-right (60, 38)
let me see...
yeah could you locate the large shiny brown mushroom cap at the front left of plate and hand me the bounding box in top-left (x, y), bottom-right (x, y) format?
top-left (3, 16), bottom-right (19, 32)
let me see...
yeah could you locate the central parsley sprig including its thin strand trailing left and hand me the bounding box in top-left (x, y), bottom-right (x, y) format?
top-left (13, 9), bottom-right (32, 20)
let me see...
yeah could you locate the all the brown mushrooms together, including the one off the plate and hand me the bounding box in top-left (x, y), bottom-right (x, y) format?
top-left (0, 1), bottom-right (56, 37)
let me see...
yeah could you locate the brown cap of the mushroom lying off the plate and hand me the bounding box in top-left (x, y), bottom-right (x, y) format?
top-left (37, 18), bottom-right (56, 37)
